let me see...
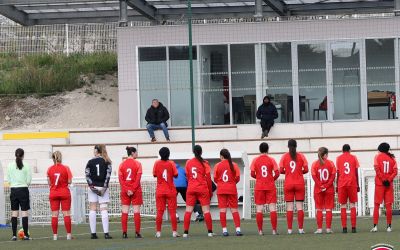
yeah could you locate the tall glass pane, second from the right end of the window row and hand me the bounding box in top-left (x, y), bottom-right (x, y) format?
top-left (331, 42), bottom-right (361, 120)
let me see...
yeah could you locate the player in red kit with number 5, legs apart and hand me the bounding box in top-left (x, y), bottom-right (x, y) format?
top-left (183, 145), bottom-right (214, 237)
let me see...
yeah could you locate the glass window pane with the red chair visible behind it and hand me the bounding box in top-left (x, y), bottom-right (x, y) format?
top-left (298, 43), bottom-right (328, 121)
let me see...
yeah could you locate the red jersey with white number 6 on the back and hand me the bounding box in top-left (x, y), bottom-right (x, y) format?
top-left (214, 160), bottom-right (240, 194)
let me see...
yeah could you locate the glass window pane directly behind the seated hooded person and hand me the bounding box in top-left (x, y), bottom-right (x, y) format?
top-left (264, 43), bottom-right (293, 122)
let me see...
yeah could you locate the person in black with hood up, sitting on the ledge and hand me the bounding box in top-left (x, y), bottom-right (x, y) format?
top-left (257, 96), bottom-right (278, 139)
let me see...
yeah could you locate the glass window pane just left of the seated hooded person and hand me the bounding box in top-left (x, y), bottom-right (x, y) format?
top-left (231, 44), bottom-right (257, 124)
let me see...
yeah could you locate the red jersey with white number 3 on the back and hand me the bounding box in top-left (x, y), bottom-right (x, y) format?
top-left (336, 152), bottom-right (360, 188)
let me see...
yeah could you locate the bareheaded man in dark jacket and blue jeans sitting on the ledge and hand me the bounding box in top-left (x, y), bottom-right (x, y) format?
top-left (145, 99), bottom-right (169, 142)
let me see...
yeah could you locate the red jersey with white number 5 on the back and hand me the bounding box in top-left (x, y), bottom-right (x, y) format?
top-left (185, 158), bottom-right (211, 193)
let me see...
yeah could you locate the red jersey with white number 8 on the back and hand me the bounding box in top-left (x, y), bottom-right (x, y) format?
top-left (250, 154), bottom-right (279, 190)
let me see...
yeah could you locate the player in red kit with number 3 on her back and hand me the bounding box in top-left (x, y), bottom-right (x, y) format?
top-left (336, 144), bottom-right (360, 233)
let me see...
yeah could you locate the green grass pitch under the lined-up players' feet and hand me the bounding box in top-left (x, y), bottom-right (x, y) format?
top-left (0, 216), bottom-right (400, 250)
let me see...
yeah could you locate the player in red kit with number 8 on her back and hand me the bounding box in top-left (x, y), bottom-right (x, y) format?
top-left (250, 142), bottom-right (279, 235)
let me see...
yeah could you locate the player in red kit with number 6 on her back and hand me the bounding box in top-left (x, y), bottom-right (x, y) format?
top-left (214, 149), bottom-right (243, 236)
